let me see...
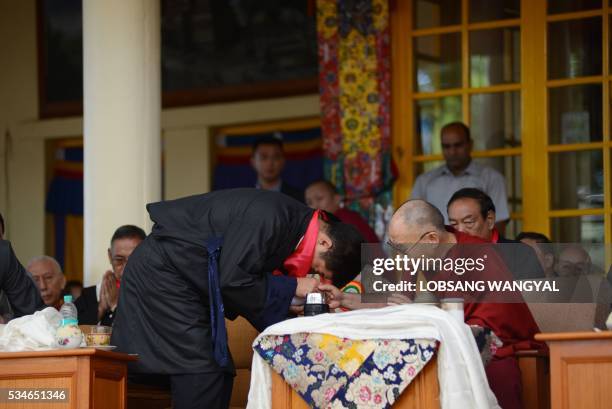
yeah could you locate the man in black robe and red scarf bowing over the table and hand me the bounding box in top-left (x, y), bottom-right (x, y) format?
top-left (112, 189), bottom-right (363, 409)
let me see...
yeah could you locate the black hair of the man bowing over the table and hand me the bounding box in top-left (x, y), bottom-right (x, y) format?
top-left (321, 217), bottom-right (365, 288)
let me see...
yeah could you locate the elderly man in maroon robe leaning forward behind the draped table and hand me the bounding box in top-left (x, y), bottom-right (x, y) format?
top-left (319, 200), bottom-right (541, 409)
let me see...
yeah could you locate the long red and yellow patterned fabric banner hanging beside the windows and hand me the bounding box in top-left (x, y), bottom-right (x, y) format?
top-left (317, 0), bottom-right (395, 235)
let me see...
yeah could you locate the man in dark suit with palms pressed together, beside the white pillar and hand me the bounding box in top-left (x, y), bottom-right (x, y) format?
top-left (74, 224), bottom-right (146, 326)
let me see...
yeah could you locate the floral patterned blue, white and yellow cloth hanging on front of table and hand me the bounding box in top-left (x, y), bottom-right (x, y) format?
top-left (254, 333), bottom-right (437, 408)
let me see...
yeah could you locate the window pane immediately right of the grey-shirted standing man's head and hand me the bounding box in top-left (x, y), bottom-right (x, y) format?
top-left (470, 91), bottom-right (521, 150)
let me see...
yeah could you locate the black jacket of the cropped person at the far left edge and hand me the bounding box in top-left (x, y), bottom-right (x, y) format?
top-left (0, 240), bottom-right (45, 318)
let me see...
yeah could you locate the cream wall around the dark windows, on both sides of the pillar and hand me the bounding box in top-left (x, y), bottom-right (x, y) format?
top-left (0, 0), bottom-right (319, 262)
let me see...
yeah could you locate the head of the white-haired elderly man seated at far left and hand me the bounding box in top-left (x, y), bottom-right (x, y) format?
top-left (26, 256), bottom-right (66, 310)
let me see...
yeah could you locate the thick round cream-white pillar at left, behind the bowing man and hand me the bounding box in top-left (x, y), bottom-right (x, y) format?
top-left (83, 0), bottom-right (161, 285)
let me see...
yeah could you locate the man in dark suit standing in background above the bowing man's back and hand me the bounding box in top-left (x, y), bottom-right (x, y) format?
top-left (251, 137), bottom-right (304, 203)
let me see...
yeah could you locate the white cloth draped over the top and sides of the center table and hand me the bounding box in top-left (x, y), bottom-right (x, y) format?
top-left (247, 304), bottom-right (499, 409)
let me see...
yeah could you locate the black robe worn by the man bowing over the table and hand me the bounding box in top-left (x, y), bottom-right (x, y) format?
top-left (112, 189), bottom-right (313, 374)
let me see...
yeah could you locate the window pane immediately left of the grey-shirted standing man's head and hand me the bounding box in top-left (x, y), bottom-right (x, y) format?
top-left (415, 96), bottom-right (461, 155)
